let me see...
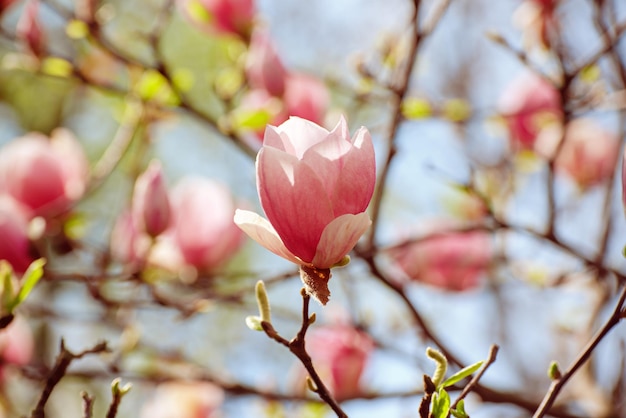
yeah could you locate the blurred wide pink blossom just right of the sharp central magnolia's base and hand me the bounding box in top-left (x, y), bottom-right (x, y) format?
top-left (391, 231), bottom-right (492, 291)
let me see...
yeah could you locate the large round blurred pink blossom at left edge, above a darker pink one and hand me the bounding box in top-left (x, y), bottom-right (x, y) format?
top-left (0, 128), bottom-right (88, 218)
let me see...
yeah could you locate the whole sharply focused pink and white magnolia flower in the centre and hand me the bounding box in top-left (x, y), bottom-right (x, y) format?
top-left (235, 117), bottom-right (376, 269)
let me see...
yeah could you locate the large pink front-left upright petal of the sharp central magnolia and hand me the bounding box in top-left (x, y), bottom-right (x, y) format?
top-left (257, 147), bottom-right (334, 262)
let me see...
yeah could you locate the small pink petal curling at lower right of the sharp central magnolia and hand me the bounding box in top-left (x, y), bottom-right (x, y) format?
top-left (312, 213), bottom-right (372, 269)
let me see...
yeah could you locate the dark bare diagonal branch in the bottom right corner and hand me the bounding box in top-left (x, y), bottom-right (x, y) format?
top-left (533, 286), bottom-right (626, 418)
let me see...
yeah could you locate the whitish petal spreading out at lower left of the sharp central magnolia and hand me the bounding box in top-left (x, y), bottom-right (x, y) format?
top-left (235, 209), bottom-right (303, 264)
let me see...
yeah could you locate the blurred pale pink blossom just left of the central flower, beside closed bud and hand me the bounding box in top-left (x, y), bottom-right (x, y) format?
top-left (154, 177), bottom-right (243, 272)
